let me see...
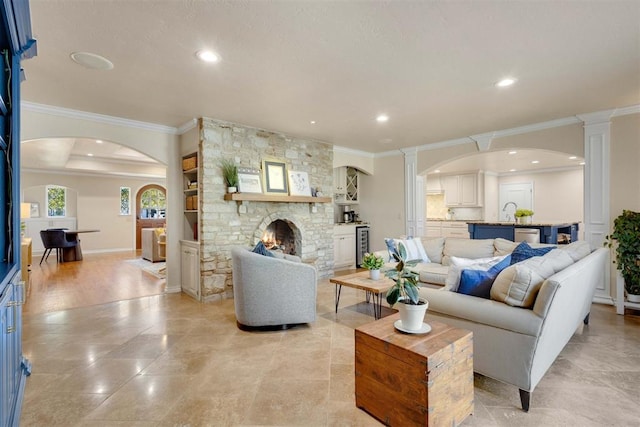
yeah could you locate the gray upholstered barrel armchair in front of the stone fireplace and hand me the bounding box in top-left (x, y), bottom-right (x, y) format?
top-left (231, 248), bottom-right (317, 329)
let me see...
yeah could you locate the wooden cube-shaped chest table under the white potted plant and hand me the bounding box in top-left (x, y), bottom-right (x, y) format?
top-left (355, 314), bottom-right (473, 426)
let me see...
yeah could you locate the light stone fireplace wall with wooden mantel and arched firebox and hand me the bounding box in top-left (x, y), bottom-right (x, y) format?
top-left (199, 118), bottom-right (334, 301)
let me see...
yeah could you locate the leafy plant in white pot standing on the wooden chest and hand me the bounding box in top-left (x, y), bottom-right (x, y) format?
top-left (385, 245), bottom-right (429, 332)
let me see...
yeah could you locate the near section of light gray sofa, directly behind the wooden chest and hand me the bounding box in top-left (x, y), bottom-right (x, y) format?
top-left (420, 244), bottom-right (608, 411)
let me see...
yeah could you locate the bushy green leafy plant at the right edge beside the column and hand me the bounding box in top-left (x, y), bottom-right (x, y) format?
top-left (604, 210), bottom-right (640, 303)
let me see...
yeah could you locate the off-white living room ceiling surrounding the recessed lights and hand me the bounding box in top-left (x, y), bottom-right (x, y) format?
top-left (17, 0), bottom-right (640, 176)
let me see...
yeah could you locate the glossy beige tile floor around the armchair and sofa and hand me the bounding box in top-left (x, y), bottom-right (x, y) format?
top-left (20, 280), bottom-right (640, 427)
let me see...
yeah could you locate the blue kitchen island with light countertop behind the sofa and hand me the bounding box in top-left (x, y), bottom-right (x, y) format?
top-left (467, 221), bottom-right (579, 244)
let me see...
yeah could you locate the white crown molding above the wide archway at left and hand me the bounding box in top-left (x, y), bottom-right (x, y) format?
top-left (20, 101), bottom-right (179, 135)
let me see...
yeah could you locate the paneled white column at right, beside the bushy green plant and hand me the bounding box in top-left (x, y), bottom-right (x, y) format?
top-left (579, 110), bottom-right (613, 304)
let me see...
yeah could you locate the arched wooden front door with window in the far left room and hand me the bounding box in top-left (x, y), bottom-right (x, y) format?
top-left (136, 184), bottom-right (167, 249)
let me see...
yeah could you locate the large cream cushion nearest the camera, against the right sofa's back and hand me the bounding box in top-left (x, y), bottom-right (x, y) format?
top-left (491, 249), bottom-right (573, 308)
